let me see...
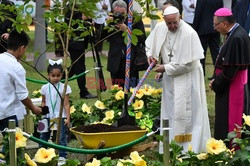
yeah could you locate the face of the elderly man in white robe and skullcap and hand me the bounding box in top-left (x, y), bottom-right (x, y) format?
top-left (164, 14), bottom-right (180, 32)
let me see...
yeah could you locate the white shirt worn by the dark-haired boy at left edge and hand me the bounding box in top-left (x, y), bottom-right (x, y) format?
top-left (0, 52), bottom-right (28, 120)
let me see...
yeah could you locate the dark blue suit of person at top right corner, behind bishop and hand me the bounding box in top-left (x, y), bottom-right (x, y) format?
top-left (233, 0), bottom-right (250, 36)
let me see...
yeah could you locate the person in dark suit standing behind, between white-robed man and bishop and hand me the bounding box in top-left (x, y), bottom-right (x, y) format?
top-left (193, 0), bottom-right (223, 80)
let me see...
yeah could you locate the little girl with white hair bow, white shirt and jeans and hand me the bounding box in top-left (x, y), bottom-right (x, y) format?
top-left (40, 59), bottom-right (71, 158)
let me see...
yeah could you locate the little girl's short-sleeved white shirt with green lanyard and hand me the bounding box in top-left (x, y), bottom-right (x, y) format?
top-left (41, 82), bottom-right (72, 118)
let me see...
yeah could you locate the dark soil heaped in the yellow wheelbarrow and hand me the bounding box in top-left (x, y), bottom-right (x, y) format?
top-left (74, 124), bottom-right (141, 133)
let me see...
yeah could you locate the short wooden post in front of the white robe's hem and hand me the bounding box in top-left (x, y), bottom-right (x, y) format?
top-left (162, 119), bottom-right (170, 166)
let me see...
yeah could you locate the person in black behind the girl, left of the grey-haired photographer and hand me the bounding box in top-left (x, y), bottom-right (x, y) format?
top-left (65, 6), bottom-right (97, 99)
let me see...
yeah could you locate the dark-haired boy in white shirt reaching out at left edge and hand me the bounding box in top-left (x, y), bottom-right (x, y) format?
top-left (0, 30), bottom-right (42, 135)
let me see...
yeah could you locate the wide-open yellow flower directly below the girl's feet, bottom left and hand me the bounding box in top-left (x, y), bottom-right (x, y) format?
top-left (35, 148), bottom-right (56, 163)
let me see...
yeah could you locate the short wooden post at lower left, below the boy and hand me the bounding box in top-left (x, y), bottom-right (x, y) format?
top-left (8, 119), bottom-right (17, 166)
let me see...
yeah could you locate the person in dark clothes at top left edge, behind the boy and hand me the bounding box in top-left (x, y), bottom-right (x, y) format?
top-left (0, 0), bottom-right (16, 53)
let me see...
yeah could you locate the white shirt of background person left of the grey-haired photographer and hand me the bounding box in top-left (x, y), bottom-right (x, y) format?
top-left (93, 0), bottom-right (111, 24)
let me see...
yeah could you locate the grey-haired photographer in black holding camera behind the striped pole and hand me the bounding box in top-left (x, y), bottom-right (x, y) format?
top-left (102, 0), bottom-right (146, 87)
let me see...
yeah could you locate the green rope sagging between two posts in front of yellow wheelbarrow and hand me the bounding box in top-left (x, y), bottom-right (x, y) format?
top-left (22, 131), bottom-right (156, 154)
